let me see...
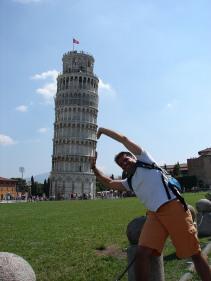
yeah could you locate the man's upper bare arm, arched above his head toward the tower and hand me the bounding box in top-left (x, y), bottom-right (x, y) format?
top-left (97, 127), bottom-right (142, 155)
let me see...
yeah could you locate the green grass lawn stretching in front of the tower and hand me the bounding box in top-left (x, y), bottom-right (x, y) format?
top-left (0, 193), bottom-right (210, 281)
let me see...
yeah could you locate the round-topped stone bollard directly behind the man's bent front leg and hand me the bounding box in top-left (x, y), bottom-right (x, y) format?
top-left (127, 217), bottom-right (165, 281)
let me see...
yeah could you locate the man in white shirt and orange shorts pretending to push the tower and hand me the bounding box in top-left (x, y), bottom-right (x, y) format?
top-left (92, 128), bottom-right (211, 281)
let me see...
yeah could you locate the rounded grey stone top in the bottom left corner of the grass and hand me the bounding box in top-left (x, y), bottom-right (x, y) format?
top-left (0, 252), bottom-right (36, 281)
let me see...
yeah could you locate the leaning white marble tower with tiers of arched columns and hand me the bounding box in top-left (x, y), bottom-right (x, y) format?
top-left (51, 51), bottom-right (99, 199)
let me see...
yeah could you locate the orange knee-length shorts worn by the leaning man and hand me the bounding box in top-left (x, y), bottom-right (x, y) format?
top-left (139, 200), bottom-right (201, 258)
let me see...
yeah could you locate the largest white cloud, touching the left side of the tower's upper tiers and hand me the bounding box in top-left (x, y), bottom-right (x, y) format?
top-left (31, 70), bottom-right (59, 102)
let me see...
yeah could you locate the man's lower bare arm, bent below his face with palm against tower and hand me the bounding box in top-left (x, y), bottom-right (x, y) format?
top-left (91, 158), bottom-right (126, 191)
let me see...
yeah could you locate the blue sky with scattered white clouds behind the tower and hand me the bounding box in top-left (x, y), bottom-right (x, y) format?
top-left (0, 0), bottom-right (211, 177)
